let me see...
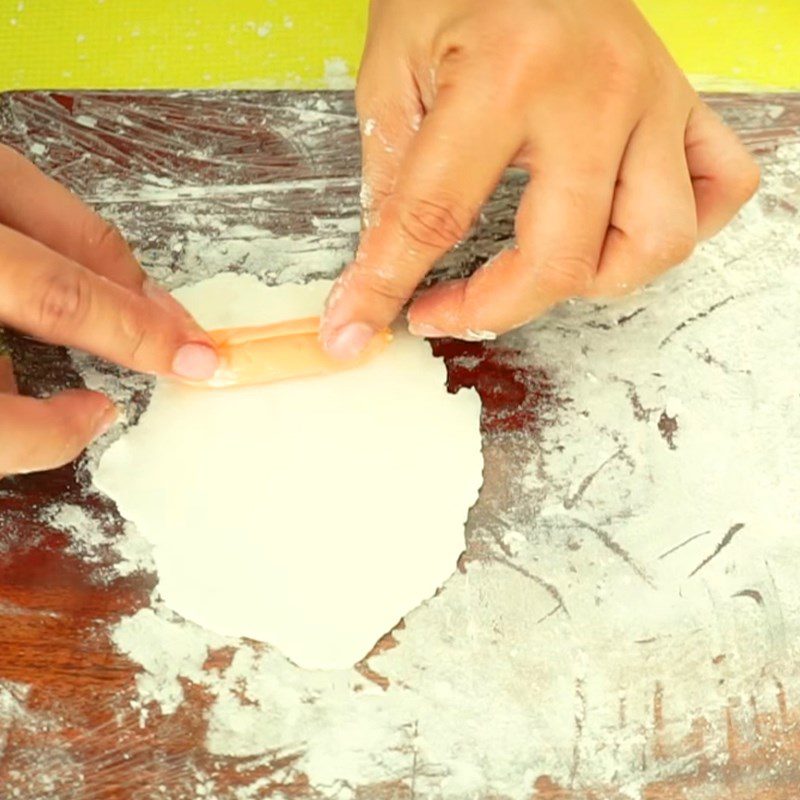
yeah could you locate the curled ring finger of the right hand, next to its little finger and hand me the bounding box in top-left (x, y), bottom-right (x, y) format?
top-left (587, 117), bottom-right (697, 297)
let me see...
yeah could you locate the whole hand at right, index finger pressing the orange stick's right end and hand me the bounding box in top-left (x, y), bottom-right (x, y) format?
top-left (322, 0), bottom-right (759, 357)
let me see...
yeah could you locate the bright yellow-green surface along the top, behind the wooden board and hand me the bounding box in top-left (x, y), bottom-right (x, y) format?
top-left (0, 0), bottom-right (800, 89)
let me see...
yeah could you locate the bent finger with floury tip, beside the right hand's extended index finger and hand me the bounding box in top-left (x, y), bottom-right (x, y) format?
top-left (409, 136), bottom-right (625, 339)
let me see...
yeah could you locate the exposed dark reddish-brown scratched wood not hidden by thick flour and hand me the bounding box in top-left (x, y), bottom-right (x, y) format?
top-left (0, 93), bottom-right (800, 800)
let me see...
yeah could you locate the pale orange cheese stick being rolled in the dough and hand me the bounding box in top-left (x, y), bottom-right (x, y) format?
top-left (187, 317), bottom-right (392, 388)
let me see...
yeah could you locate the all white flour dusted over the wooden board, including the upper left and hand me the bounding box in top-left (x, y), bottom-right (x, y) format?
top-left (0, 90), bottom-right (800, 800)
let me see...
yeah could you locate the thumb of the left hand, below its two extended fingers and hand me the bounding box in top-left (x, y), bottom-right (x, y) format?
top-left (0, 389), bottom-right (117, 475)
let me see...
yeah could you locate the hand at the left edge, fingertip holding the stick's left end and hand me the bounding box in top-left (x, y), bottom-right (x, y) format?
top-left (0, 145), bottom-right (218, 476)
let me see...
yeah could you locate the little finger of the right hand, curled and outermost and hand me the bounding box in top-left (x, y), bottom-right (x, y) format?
top-left (685, 102), bottom-right (759, 239)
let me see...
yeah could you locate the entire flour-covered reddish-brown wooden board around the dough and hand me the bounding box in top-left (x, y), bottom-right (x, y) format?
top-left (0, 94), bottom-right (800, 800)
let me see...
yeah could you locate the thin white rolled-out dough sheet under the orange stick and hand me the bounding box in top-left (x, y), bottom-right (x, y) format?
top-left (95, 273), bottom-right (483, 669)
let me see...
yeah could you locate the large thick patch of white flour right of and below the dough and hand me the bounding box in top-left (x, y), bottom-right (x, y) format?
top-left (106, 145), bottom-right (800, 798)
